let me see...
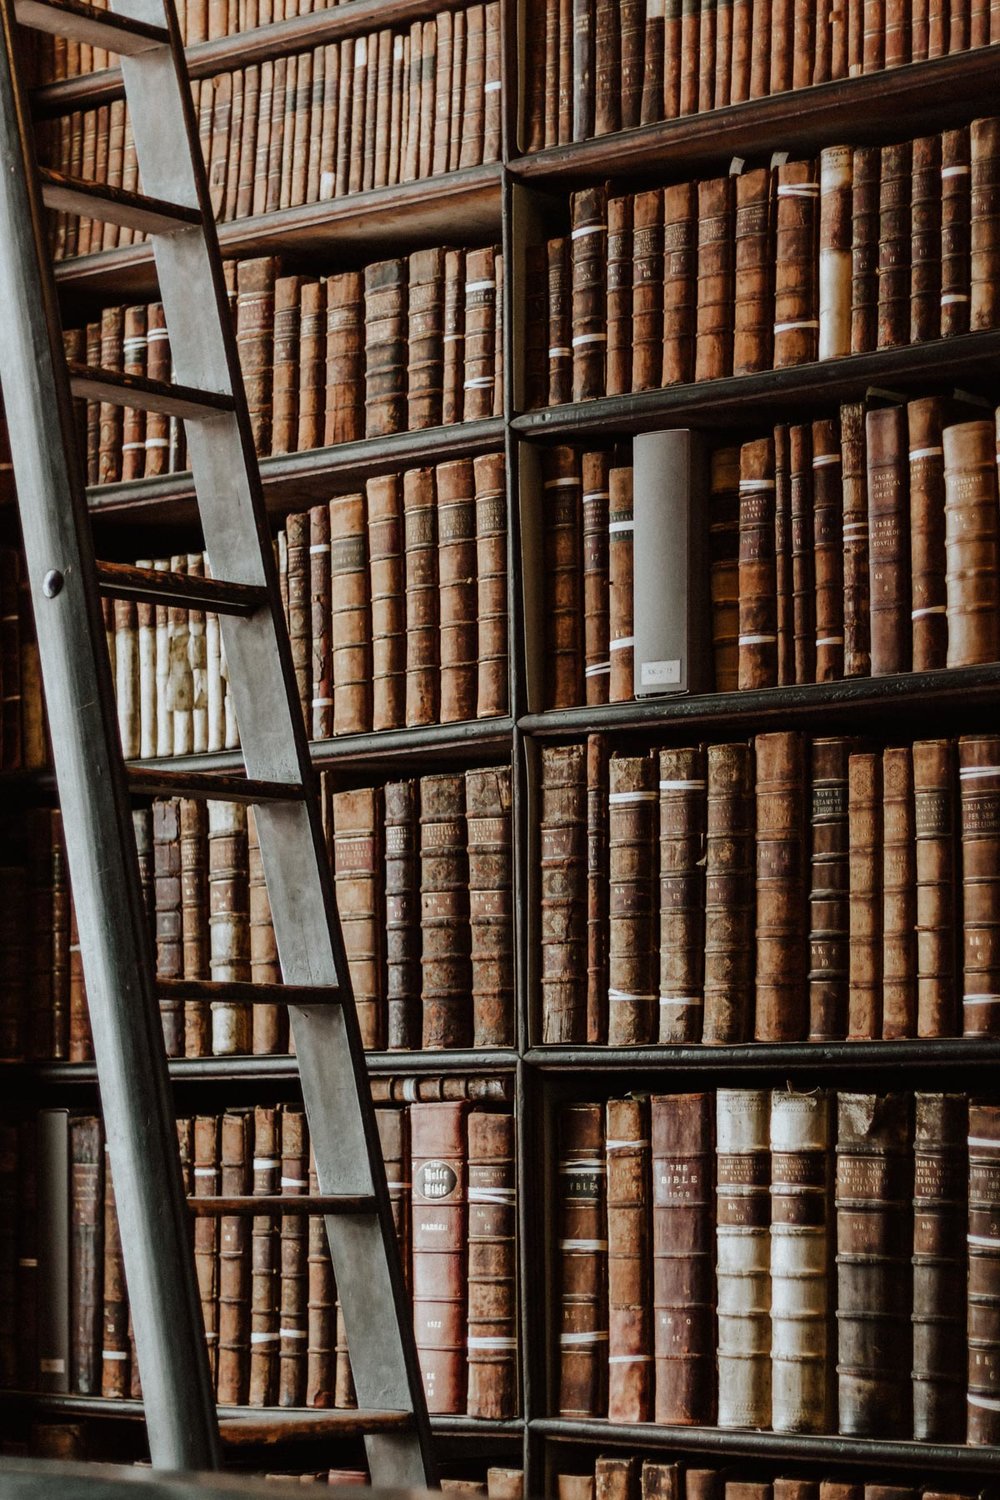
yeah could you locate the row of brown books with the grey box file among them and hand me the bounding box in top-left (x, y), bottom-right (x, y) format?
top-left (541, 396), bottom-right (1000, 708)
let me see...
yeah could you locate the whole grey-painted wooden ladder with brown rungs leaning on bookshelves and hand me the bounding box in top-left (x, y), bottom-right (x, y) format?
top-left (0, 0), bottom-right (433, 1487)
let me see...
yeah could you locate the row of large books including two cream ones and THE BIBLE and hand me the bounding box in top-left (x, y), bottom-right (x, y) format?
top-left (556, 1089), bottom-right (1000, 1445)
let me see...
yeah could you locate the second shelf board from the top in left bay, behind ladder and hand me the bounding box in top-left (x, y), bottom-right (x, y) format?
top-left (55, 164), bottom-right (501, 305)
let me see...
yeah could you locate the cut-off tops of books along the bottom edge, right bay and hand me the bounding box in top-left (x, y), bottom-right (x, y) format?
top-left (553, 1454), bottom-right (976, 1500)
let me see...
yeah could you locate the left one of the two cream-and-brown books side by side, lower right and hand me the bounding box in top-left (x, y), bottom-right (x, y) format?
top-left (715, 1089), bottom-right (771, 1428)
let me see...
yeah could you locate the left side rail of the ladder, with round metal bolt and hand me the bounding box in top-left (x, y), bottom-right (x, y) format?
top-left (0, 0), bottom-right (219, 1469)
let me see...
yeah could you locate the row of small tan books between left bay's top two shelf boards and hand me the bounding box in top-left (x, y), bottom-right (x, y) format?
top-left (37, 0), bottom-right (501, 238)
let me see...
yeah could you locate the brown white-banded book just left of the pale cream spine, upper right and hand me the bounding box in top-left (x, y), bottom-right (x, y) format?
top-left (774, 162), bottom-right (820, 369)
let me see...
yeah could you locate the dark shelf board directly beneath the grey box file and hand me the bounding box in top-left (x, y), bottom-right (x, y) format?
top-left (517, 663), bottom-right (1000, 740)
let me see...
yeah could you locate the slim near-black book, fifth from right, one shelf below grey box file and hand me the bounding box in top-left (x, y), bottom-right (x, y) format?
top-left (808, 738), bottom-right (850, 1041)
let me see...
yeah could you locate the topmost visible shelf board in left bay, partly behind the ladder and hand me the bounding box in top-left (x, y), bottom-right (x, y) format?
top-left (31, 0), bottom-right (479, 116)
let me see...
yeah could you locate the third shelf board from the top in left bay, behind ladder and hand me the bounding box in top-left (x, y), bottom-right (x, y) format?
top-left (87, 417), bottom-right (504, 527)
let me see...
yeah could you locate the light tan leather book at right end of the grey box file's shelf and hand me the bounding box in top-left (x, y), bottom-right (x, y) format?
top-left (943, 422), bottom-right (1000, 666)
